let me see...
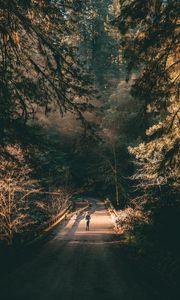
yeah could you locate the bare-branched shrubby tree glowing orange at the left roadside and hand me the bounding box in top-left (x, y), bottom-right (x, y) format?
top-left (0, 145), bottom-right (38, 245)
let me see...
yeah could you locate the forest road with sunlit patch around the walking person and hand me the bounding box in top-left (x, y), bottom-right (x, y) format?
top-left (0, 199), bottom-right (165, 300)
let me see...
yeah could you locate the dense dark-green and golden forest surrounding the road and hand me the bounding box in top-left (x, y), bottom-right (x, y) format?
top-left (0, 0), bottom-right (180, 296)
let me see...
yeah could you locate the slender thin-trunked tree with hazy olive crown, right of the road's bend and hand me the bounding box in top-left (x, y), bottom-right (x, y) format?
top-left (101, 80), bottom-right (142, 208)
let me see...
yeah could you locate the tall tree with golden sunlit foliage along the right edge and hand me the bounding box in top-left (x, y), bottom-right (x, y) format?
top-left (114, 0), bottom-right (180, 206)
